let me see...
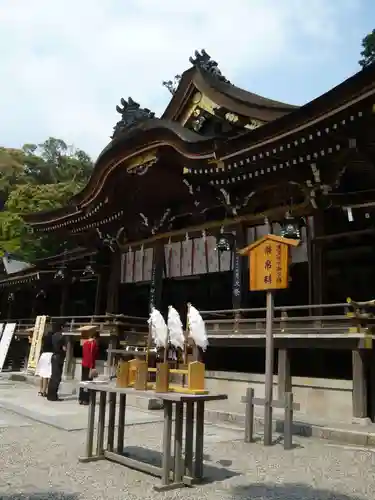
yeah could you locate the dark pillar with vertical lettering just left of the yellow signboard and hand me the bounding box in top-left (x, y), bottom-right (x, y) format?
top-left (232, 225), bottom-right (247, 318)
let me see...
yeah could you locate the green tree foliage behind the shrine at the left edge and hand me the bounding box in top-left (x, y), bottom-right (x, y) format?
top-left (0, 137), bottom-right (93, 261)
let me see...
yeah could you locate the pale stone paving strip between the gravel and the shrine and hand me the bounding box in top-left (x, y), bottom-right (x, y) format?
top-left (0, 373), bottom-right (375, 446)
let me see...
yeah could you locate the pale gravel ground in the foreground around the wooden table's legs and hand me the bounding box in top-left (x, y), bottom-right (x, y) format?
top-left (0, 410), bottom-right (375, 500)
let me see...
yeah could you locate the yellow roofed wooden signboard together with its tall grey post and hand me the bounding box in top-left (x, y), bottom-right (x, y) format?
top-left (239, 234), bottom-right (299, 446)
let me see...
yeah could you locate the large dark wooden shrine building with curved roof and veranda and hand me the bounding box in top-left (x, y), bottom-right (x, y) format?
top-left (0, 52), bottom-right (375, 421)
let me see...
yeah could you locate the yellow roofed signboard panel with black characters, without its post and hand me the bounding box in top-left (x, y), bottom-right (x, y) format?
top-left (239, 234), bottom-right (299, 291)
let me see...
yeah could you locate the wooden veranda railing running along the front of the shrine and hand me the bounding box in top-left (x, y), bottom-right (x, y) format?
top-left (7, 302), bottom-right (375, 345)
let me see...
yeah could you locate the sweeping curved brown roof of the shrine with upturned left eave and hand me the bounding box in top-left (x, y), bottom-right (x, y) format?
top-left (25, 53), bottom-right (375, 230)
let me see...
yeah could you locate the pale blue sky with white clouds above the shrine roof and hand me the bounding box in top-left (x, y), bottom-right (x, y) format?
top-left (0, 0), bottom-right (375, 159)
